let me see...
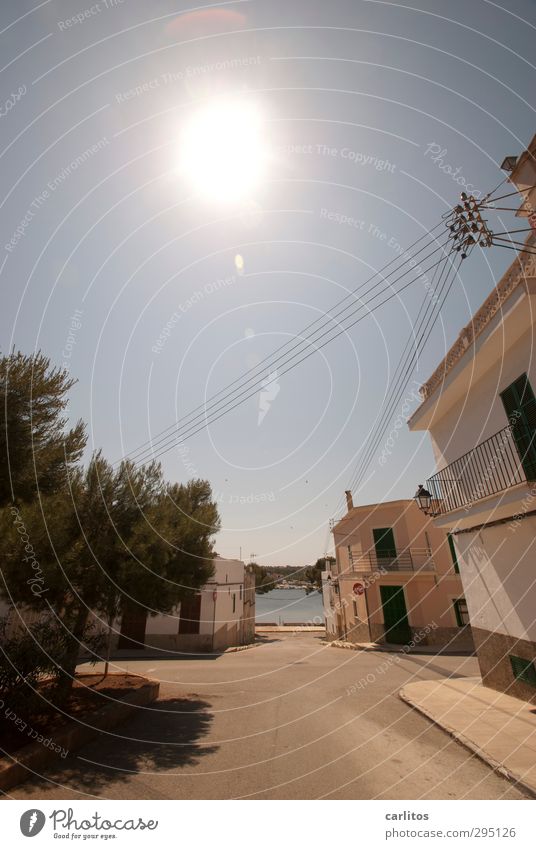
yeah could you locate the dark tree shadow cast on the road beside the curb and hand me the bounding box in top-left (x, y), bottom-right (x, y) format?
top-left (16, 698), bottom-right (218, 798)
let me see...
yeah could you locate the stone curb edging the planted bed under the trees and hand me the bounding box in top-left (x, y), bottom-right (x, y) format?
top-left (0, 680), bottom-right (160, 790)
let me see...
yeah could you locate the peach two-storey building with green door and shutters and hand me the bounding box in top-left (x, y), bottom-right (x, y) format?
top-left (322, 493), bottom-right (473, 650)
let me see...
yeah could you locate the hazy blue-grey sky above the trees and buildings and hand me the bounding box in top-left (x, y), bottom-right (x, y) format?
top-left (0, 0), bottom-right (536, 566)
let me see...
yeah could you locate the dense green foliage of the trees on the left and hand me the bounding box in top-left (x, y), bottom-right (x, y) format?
top-left (0, 354), bottom-right (220, 695)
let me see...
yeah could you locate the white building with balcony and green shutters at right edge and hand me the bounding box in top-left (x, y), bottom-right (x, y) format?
top-left (409, 137), bottom-right (536, 702)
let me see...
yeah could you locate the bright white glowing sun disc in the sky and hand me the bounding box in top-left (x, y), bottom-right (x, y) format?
top-left (179, 100), bottom-right (267, 203)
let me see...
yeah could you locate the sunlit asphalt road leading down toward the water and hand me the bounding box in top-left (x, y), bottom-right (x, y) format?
top-left (3, 634), bottom-right (525, 799)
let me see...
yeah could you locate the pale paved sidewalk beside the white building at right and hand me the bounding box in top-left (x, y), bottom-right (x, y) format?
top-left (399, 678), bottom-right (536, 796)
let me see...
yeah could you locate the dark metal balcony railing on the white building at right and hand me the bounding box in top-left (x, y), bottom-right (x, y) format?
top-left (426, 423), bottom-right (536, 516)
